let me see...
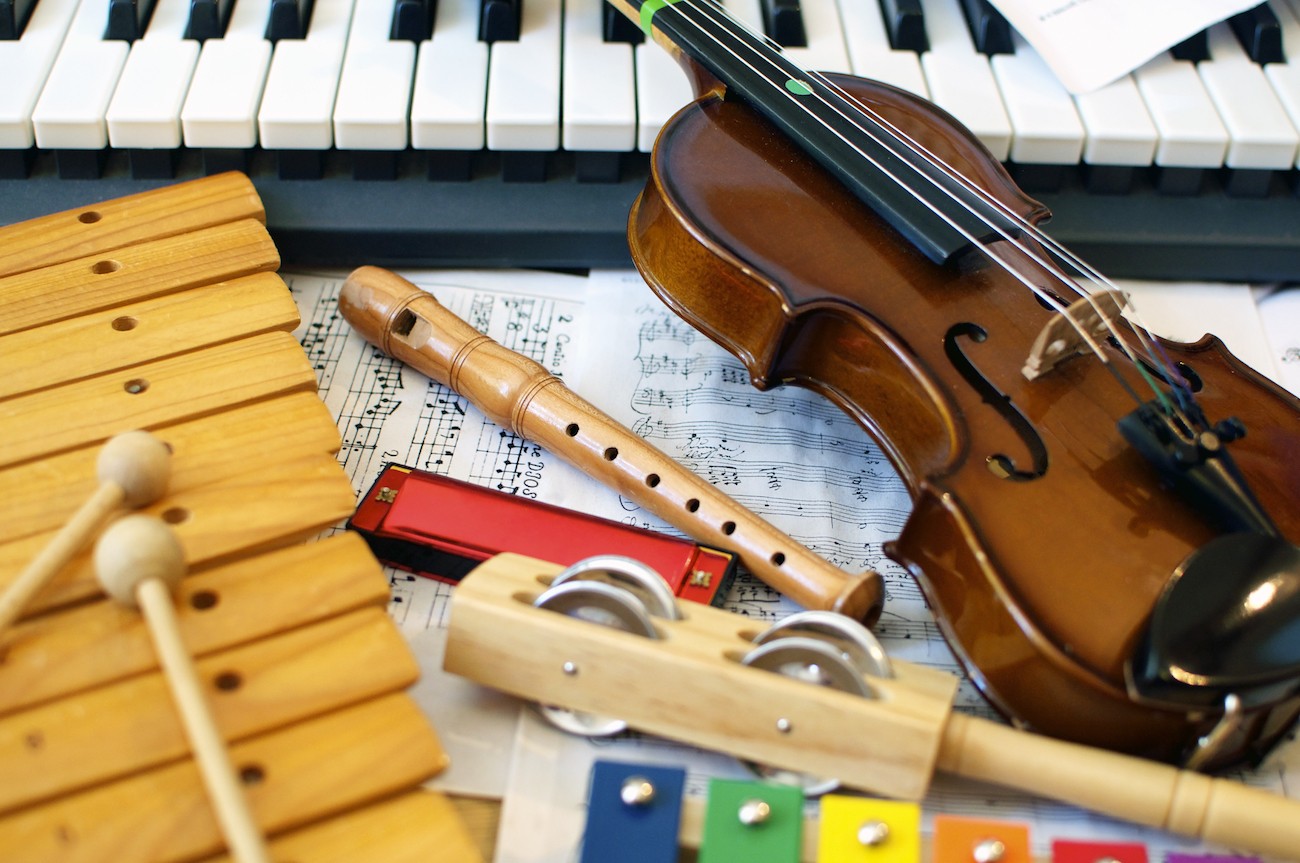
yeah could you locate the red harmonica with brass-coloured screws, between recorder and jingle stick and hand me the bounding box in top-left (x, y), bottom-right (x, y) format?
top-left (347, 464), bottom-right (736, 606)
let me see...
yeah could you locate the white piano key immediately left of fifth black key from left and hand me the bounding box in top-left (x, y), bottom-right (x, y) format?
top-left (334, 0), bottom-right (415, 149)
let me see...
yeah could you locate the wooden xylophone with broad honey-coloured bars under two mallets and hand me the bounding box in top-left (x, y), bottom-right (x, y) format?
top-left (0, 174), bottom-right (478, 863)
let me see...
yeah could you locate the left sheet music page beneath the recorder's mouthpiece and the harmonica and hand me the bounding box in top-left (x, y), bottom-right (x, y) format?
top-left (282, 272), bottom-right (600, 797)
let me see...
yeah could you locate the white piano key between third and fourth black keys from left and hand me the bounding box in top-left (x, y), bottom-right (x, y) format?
top-left (181, 0), bottom-right (272, 149)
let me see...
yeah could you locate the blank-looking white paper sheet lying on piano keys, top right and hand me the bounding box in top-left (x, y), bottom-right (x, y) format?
top-left (991, 0), bottom-right (1260, 94)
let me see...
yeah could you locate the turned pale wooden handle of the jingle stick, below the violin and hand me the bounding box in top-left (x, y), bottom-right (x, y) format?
top-left (937, 714), bottom-right (1300, 860)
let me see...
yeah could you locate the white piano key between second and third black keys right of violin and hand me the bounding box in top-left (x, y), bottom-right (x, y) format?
top-left (920, 0), bottom-right (1011, 161)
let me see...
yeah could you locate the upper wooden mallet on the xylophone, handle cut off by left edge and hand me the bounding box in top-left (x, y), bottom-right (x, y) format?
top-left (0, 432), bottom-right (172, 632)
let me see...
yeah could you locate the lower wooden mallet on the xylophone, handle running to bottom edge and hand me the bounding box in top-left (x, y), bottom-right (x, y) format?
top-left (95, 515), bottom-right (270, 863)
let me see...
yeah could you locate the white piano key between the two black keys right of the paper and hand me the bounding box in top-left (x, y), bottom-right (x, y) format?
top-left (1132, 52), bottom-right (1227, 168)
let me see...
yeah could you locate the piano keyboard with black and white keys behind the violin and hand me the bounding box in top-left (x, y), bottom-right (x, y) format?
top-left (0, 0), bottom-right (1300, 281)
